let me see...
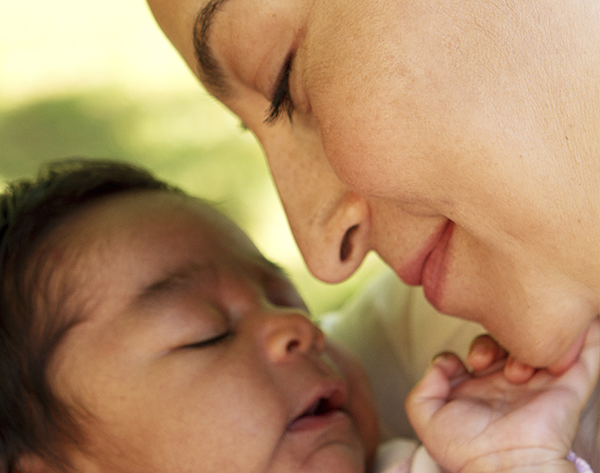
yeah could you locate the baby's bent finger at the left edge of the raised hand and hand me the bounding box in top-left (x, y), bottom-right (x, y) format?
top-left (405, 353), bottom-right (469, 433)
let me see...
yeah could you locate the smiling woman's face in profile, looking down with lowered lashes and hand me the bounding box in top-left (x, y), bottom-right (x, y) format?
top-left (149, 0), bottom-right (600, 366)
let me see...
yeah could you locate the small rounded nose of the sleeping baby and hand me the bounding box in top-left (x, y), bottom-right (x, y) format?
top-left (262, 310), bottom-right (325, 363)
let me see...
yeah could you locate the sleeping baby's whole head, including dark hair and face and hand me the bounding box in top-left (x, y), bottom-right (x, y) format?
top-left (0, 162), bottom-right (377, 473)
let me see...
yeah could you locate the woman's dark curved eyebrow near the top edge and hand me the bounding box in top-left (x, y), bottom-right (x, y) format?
top-left (193, 0), bottom-right (236, 96)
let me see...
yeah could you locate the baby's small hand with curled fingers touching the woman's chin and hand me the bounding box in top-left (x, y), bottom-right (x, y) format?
top-left (406, 320), bottom-right (600, 473)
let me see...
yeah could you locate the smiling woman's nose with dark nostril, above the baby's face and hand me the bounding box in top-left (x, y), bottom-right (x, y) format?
top-left (265, 126), bottom-right (371, 283)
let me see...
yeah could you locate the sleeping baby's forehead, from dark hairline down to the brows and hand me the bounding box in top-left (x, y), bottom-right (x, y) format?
top-left (41, 191), bottom-right (287, 320)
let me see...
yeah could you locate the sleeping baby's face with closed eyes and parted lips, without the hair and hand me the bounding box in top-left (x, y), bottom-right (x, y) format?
top-left (45, 192), bottom-right (377, 473)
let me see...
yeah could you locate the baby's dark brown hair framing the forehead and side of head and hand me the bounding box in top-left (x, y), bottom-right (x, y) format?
top-left (0, 159), bottom-right (180, 473)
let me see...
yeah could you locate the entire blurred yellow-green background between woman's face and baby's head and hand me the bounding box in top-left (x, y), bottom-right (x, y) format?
top-left (0, 0), bottom-right (381, 314)
